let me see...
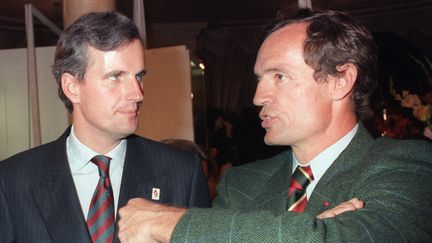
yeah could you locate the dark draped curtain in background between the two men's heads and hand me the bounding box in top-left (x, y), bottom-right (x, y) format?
top-left (196, 25), bottom-right (262, 114)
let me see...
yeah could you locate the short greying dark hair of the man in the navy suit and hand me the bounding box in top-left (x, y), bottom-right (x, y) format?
top-left (52, 12), bottom-right (142, 112)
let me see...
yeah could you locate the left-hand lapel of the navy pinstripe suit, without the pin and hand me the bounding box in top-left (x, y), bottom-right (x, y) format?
top-left (33, 128), bottom-right (90, 242)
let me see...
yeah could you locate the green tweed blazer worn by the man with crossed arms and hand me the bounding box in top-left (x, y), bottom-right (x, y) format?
top-left (171, 124), bottom-right (432, 243)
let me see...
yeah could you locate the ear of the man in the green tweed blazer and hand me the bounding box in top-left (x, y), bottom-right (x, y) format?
top-left (332, 63), bottom-right (357, 100)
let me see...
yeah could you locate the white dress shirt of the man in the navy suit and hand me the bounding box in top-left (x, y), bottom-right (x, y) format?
top-left (66, 126), bottom-right (127, 219)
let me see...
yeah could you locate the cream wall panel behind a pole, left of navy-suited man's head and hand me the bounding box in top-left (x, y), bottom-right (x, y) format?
top-left (0, 47), bottom-right (68, 160)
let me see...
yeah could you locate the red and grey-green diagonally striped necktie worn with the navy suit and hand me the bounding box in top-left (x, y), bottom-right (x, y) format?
top-left (87, 155), bottom-right (114, 243)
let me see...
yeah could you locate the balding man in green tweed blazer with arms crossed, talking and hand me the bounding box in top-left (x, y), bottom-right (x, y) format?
top-left (119, 8), bottom-right (432, 242)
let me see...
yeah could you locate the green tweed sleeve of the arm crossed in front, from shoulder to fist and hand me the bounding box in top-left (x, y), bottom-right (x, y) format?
top-left (172, 141), bottom-right (432, 243)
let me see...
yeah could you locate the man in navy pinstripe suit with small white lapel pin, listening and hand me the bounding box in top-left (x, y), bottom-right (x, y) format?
top-left (0, 12), bottom-right (211, 243)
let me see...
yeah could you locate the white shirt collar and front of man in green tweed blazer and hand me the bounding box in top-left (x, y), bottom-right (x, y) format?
top-left (291, 124), bottom-right (359, 199)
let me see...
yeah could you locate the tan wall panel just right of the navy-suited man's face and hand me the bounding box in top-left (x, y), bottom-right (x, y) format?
top-left (137, 46), bottom-right (194, 141)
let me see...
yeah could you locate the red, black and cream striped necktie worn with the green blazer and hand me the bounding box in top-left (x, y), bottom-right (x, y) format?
top-left (287, 166), bottom-right (314, 213)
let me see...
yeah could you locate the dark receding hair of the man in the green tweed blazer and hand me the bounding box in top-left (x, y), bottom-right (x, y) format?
top-left (266, 9), bottom-right (377, 119)
